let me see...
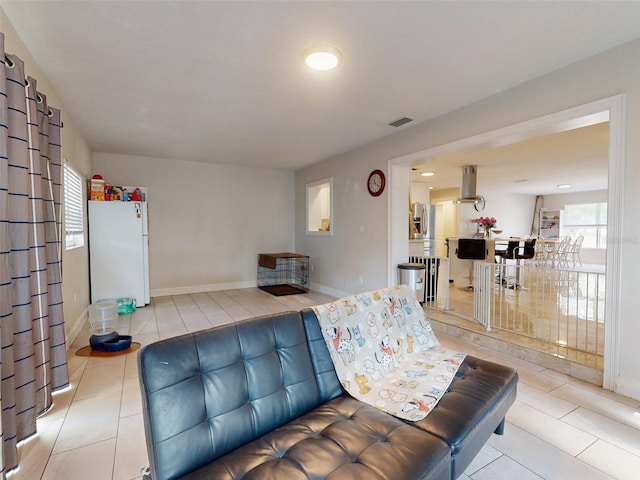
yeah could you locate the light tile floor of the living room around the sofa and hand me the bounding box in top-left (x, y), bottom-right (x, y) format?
top-left (8, 288), bottom-right (640, 480)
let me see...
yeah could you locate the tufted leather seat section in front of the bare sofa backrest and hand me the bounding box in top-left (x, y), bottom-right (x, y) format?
top-left (181, 397), bottom-right (451, 480)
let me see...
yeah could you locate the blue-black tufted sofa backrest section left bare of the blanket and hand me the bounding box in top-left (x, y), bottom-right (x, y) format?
top-left (138, 312), bottom-right (322, 480)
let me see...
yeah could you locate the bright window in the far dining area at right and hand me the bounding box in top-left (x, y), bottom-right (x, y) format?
top-left (560, 202), bottom-right (607, 248)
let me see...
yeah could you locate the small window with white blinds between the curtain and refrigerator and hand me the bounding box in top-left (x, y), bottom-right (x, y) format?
top-left (64, 159), bottom-right (84, 250)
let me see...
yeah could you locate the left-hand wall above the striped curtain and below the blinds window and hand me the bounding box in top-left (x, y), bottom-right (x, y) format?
top-left (0, 7), bottom-right (91, 341)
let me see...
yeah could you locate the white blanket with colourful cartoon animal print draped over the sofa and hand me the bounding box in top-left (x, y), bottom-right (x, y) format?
top-left (313, 285), bottom-right (465, 421)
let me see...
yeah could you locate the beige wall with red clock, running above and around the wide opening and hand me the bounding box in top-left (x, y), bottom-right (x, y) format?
top-left (296, 37), bottom-right (640, 398)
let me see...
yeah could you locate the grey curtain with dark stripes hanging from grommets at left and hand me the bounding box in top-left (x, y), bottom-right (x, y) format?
top-left (0, 32), bottom-right (69, 479)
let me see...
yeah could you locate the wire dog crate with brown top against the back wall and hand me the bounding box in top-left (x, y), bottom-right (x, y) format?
top-left (258, 253), bottom-right (309, 296)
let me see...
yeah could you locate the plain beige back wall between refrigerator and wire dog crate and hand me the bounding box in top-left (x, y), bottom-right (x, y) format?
top-left (93, 153), bottom-right (304, 296)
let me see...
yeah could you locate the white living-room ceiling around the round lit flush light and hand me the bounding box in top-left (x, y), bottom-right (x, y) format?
top-left (2, 0), bottom-right (640, 172)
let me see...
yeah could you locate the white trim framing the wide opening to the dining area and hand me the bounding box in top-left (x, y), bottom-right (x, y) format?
top-left (387, 94), bottom-right (626, 391)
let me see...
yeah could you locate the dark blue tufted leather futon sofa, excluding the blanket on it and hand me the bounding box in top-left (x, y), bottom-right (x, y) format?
top-left (138, 309), bottom-right (518, 480)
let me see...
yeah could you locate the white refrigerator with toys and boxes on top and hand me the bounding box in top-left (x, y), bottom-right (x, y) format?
top-left (88, 200), bottom-right (149, 307)
